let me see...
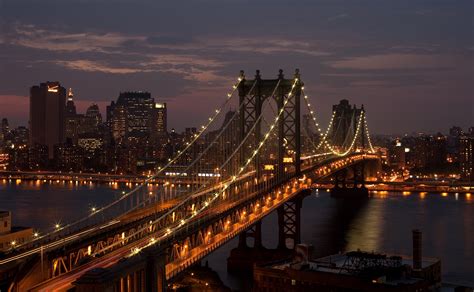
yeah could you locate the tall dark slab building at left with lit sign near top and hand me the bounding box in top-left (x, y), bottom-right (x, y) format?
top-left (29, 81), bottom-right (66, 158)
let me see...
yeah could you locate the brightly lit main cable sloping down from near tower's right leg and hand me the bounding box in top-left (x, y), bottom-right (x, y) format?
top-left (96, 78), bottom-right (298, 253)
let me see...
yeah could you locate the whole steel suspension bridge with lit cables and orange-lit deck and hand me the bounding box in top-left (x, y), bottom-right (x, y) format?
top-left (0, 70), bottom-right (379, 291)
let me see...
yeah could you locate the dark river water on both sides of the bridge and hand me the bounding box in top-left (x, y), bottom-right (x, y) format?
top-left (0, 183), bottom-right (474, 288)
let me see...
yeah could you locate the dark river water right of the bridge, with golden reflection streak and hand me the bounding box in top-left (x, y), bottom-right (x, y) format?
top-left (205, 190), bottom-right (474, 290)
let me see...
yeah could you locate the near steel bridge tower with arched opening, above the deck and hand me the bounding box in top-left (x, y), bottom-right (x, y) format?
top-left (238, 69), bottom-right (303, 179)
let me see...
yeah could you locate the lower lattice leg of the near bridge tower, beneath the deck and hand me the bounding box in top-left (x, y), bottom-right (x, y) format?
top-left (278, 197), bottom-right (302, 249)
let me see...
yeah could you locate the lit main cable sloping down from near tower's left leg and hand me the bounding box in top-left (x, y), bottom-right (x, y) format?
top-left (3, 76), bottom-right (243, 260)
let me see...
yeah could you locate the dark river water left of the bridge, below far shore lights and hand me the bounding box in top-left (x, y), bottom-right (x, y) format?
top-left (0, 180), bottom-right (178, 233)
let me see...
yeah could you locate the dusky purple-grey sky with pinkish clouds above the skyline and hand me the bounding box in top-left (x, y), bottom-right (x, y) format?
top-left (0, 0), bottom-right (474, 133)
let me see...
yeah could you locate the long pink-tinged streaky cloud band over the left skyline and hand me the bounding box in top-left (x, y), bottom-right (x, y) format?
top-left (6, 23), bottom-right (336, 83)
